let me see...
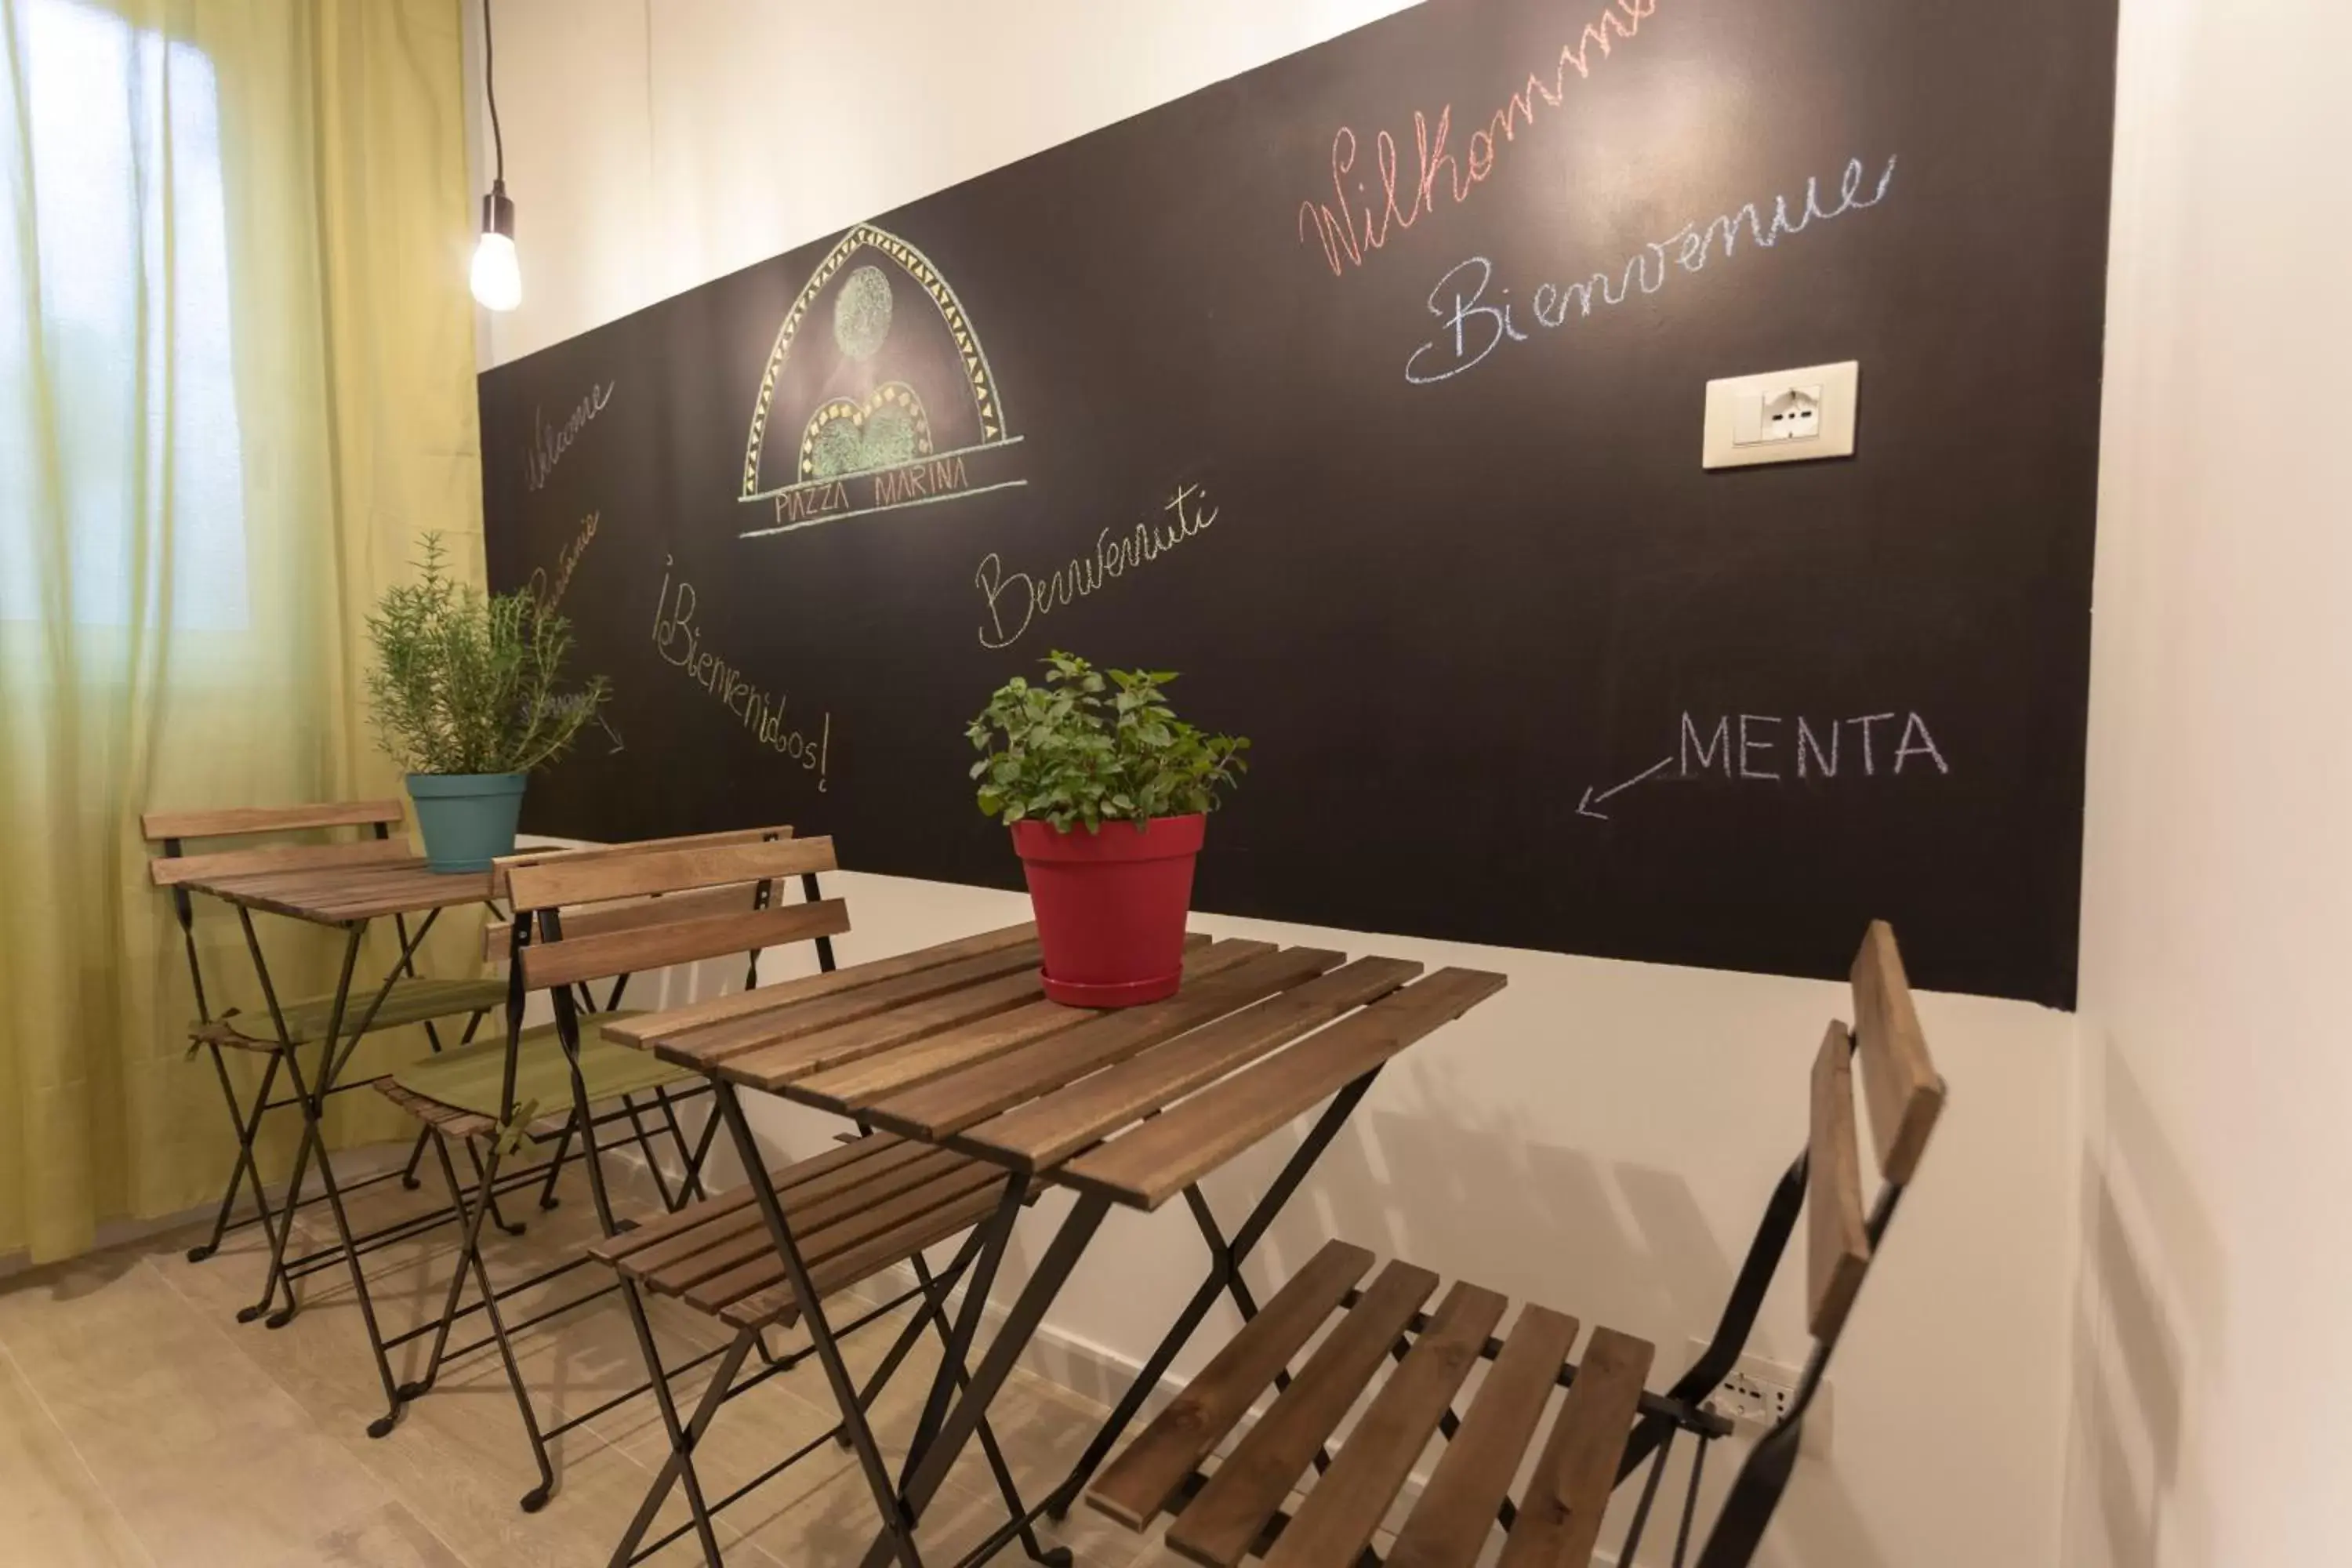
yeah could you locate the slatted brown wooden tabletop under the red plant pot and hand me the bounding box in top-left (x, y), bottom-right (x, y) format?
top-left (607, 926), bottom-right (1503, 1208)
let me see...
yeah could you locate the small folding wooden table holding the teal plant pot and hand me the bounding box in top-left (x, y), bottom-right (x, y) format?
top-left (181, 858), bottom-right (506, 1436)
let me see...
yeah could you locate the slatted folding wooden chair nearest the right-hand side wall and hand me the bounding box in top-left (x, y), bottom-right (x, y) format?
top-left (1087, 924), bottom-right (1945, 1568)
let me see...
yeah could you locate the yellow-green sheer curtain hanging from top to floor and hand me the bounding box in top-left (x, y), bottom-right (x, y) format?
top-left (0, 0), bottom-right (480, 1260)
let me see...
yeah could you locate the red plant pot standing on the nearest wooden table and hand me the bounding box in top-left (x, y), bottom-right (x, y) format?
top-left (1014, 813), bottom-right (1207, 1006)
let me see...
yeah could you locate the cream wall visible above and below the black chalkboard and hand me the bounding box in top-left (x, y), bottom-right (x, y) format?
top-left (463, 0), bottom-right (2079, 1568)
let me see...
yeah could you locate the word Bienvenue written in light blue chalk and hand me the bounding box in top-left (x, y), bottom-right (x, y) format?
top-left (1404, 158), bottom-right (1896, 386)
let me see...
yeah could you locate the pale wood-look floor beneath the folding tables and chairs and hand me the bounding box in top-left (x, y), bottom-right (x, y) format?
top-left (0, 1142), bottom-right (1178, 1568)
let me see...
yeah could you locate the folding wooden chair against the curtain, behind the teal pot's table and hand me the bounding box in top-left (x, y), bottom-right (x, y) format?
top-left (139, 799), bottom-right (506, 1288)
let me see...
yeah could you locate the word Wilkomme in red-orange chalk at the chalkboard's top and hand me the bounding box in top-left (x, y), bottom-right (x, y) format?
top-left (1298, 0), bottom-right (1658, 278)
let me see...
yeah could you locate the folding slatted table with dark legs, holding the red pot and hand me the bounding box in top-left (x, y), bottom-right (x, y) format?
top-left (607, 926), bottom-right (1503, 1568)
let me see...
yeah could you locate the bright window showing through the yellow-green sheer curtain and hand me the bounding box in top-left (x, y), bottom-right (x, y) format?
top-left (0, 0), bottom-right (247, 630)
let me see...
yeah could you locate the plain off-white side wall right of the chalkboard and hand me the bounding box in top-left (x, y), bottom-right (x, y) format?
top-left (2065, 0), bottom-right (2352, 1568)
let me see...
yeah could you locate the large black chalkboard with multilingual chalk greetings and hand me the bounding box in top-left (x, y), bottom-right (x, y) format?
top-left (482, 0), bottom-right (2114, 1006)
